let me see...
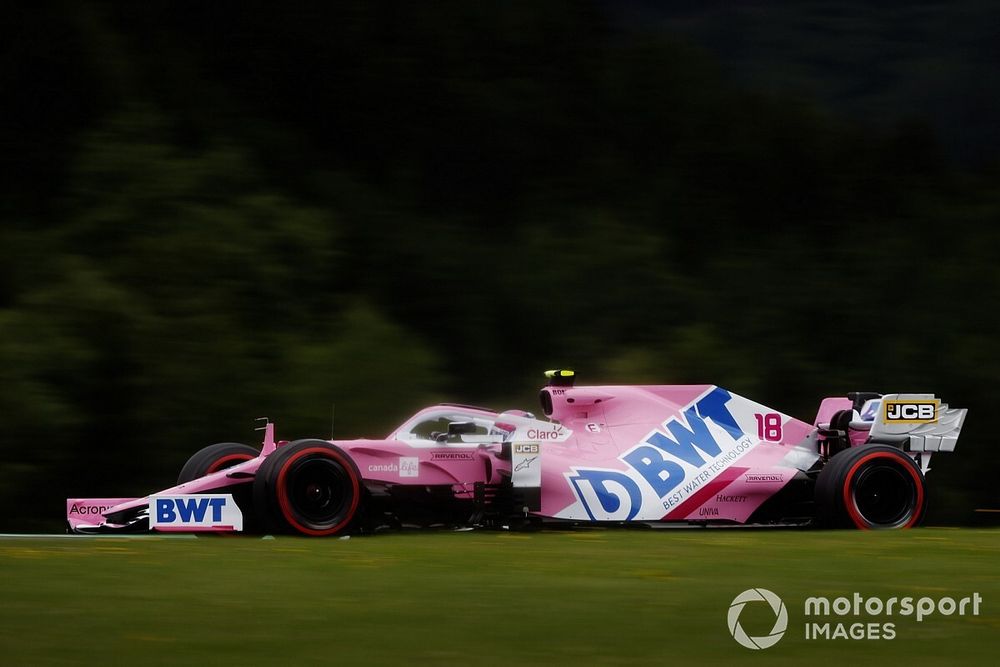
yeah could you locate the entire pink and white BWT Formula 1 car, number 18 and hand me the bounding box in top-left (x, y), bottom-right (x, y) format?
top-left (66, 371), bottom-right (966, 536)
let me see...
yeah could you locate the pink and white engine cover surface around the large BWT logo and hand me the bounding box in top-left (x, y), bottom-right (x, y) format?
top-left (541, 385), bottom-right (817, 523)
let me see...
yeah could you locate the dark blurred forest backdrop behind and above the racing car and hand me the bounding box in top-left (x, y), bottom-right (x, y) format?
top-left (0, 1), bottom-right (1000, 530)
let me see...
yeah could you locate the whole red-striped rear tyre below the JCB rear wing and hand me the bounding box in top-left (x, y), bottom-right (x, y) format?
top-left (816, 445), bottom-right (927, 530)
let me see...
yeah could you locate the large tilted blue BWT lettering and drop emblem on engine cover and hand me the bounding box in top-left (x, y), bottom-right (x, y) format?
top-left (568, 387), bottom-right (749, 521)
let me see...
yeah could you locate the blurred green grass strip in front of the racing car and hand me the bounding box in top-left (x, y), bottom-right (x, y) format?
top-left (0, 529), bottom-right (1000, 667)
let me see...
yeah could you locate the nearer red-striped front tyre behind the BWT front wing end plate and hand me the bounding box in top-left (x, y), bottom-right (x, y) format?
top-left (253, 440), bottom-right (364, 536)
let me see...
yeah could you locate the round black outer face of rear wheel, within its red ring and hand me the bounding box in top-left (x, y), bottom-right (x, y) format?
top-left (851, 460), bottom-right (919, 528)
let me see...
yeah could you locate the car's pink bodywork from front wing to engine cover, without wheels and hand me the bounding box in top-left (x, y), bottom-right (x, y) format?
top-left (67, 385), bottom-right (828, 530)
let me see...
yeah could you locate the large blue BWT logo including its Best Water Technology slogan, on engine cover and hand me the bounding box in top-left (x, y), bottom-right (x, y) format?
top-left (567, 387), bottom-right (753, 521)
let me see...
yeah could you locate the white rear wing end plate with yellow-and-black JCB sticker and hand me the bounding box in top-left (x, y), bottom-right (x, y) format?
top-left (862, 394), bottom-right (968, 452)
